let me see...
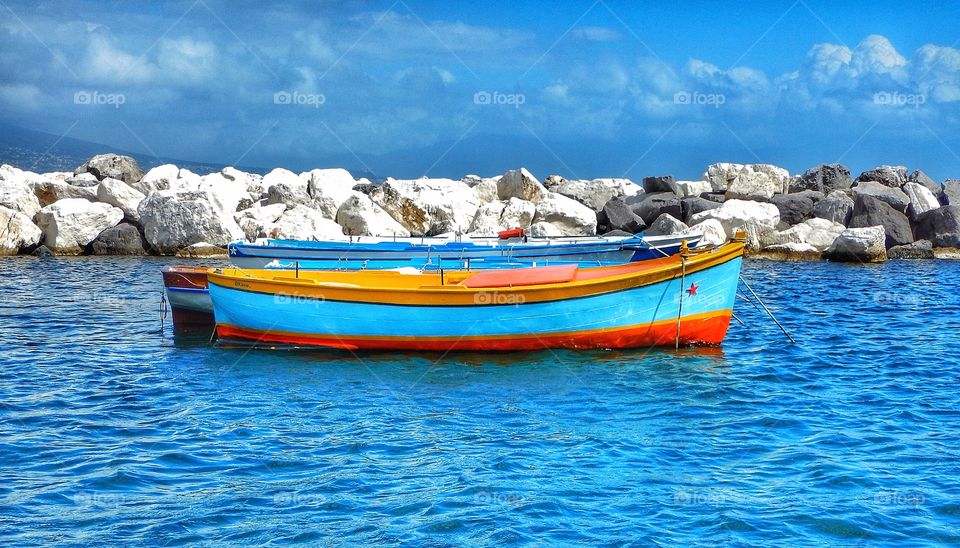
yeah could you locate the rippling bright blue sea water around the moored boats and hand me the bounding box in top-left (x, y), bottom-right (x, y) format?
top-left (0, 258), bottom-right (960, 545)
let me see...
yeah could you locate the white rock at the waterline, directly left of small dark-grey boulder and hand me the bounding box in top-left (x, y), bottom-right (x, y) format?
top-left (37, 198), bottom-right (123, 254)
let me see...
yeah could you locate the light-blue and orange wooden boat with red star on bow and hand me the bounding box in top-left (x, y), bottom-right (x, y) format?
top-left (207, 242), bottom-right (743, 352)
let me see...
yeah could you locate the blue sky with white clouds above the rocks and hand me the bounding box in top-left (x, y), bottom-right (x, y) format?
top-left (0, 0), bottom-right (960, 180)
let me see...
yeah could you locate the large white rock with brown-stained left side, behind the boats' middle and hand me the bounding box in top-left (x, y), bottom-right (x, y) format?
top-left (370, 179), bottom-right (480, 236)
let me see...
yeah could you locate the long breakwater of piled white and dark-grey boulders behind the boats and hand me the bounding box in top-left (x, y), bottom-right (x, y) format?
top-left (0, 154), bottom-right (960, 262)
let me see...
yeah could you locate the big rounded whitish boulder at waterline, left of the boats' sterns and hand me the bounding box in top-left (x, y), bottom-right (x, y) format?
top-left (137, 190), bottom-right (244, 254)
